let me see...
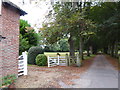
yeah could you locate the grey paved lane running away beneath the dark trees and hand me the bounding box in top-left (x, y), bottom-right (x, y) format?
top-left (59, 55), bottom-right (118, 88)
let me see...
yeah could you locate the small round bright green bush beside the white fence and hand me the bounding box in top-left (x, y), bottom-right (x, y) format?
top-left (36, 54), bottom-right (47, 66)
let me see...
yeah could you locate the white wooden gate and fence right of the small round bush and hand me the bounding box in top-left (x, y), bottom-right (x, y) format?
top-left (48, 55), bottom-right (67, 67)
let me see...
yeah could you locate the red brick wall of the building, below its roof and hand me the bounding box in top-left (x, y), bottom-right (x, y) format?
top-left (0, 6), bottom-right (20, 76)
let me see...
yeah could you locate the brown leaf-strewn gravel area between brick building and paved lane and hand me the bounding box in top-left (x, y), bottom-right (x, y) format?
top-left (15, 59), bottom-right (93, 88)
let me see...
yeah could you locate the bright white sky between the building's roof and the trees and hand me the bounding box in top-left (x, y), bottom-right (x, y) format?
top-left (10, 0), bottom-right (51, 32)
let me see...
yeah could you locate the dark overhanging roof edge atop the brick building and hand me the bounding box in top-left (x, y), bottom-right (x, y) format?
top-left (2, 0), bottom-right (27, 16)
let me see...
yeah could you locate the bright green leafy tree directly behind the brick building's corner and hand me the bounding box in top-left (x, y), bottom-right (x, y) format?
top-left (19, 20), bottom-right (38, 54)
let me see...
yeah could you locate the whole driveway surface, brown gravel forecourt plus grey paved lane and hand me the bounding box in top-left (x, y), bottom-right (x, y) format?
top-left (15, 55), bottom-right (118, 90)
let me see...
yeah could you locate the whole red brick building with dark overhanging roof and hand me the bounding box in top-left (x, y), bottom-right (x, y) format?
top-left (0, 0), bottom-right (26, 77)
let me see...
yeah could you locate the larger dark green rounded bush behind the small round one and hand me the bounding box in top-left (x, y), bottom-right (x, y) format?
top-left (28, 47), bottom-right (44, 65)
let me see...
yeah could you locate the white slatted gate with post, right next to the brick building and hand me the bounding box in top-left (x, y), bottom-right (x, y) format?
top-left (18, 52), bottom-right (27, 76)
